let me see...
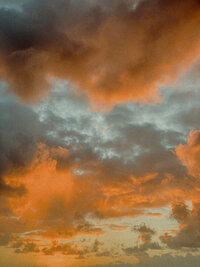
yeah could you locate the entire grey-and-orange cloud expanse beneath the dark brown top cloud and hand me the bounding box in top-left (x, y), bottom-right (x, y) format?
top-left (0, 66), bottom-right (200, 267)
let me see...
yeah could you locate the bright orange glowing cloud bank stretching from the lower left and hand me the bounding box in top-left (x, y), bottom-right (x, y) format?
top-left (0, 144), bottom-right (170, 249)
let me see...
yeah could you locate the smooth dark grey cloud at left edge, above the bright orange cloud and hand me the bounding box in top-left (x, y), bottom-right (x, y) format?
top-left (0, 93), bottom-right (43, 197)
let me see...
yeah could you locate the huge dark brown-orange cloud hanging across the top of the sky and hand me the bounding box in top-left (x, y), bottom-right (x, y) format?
top-left (0, 0), bottom-right (200, 104)
